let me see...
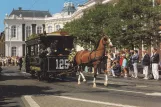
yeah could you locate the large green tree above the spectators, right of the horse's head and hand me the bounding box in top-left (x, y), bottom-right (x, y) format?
top-left (106, 0), bottom-right (160, 48)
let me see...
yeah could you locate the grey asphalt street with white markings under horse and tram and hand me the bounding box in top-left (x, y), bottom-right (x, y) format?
top-left (0, 66), bottom-right (161, 107)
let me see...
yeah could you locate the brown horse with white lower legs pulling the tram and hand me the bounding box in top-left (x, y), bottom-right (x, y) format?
top-left (74, 36), bottom-right (110, 87)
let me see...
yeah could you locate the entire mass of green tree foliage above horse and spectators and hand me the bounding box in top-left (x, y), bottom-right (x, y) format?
top-left (64, 0), bottom-right (161, 48)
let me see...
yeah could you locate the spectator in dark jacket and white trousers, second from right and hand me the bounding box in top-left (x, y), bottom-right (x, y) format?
top-left (142, 50), bottom-right (150, 80)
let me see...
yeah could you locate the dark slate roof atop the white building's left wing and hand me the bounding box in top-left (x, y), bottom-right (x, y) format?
top-left (10, 8), bottom-right (52, 17)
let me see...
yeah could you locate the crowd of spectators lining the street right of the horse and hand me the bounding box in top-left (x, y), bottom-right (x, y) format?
top-left (106, 48), bottom-right (160, 80)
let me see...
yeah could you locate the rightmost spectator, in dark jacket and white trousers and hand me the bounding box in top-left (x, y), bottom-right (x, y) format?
top-left (151, 48), bottom-right (159, 80)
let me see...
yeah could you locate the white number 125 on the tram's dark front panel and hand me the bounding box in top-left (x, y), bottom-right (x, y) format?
top-left (56, 59), bottom-right (70, 69)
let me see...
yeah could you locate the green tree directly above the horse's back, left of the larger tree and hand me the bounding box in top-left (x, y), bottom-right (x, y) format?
top-left (64, 4), bottom-right (111, 47)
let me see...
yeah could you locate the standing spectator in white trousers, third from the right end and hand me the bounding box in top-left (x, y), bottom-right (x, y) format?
top-left (132, 50), bottom-right (139, 78)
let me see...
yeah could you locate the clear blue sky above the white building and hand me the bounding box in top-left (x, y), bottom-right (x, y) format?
top-left (0, 0), bottom-right (87, 32)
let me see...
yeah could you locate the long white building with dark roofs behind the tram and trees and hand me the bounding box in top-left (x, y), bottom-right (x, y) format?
top-left (4, 0), bottom-right (111, 56)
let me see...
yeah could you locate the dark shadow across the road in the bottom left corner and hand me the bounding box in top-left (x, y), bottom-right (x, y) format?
top-left (0, 85), bottom-right (66, 107)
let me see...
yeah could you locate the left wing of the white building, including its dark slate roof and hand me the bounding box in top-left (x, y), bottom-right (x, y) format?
top-left (4, 8), bottom-right (52, 56)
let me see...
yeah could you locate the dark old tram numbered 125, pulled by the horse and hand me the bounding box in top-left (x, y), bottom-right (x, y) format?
top-left (26, 33), bottom-right (73, 80)
